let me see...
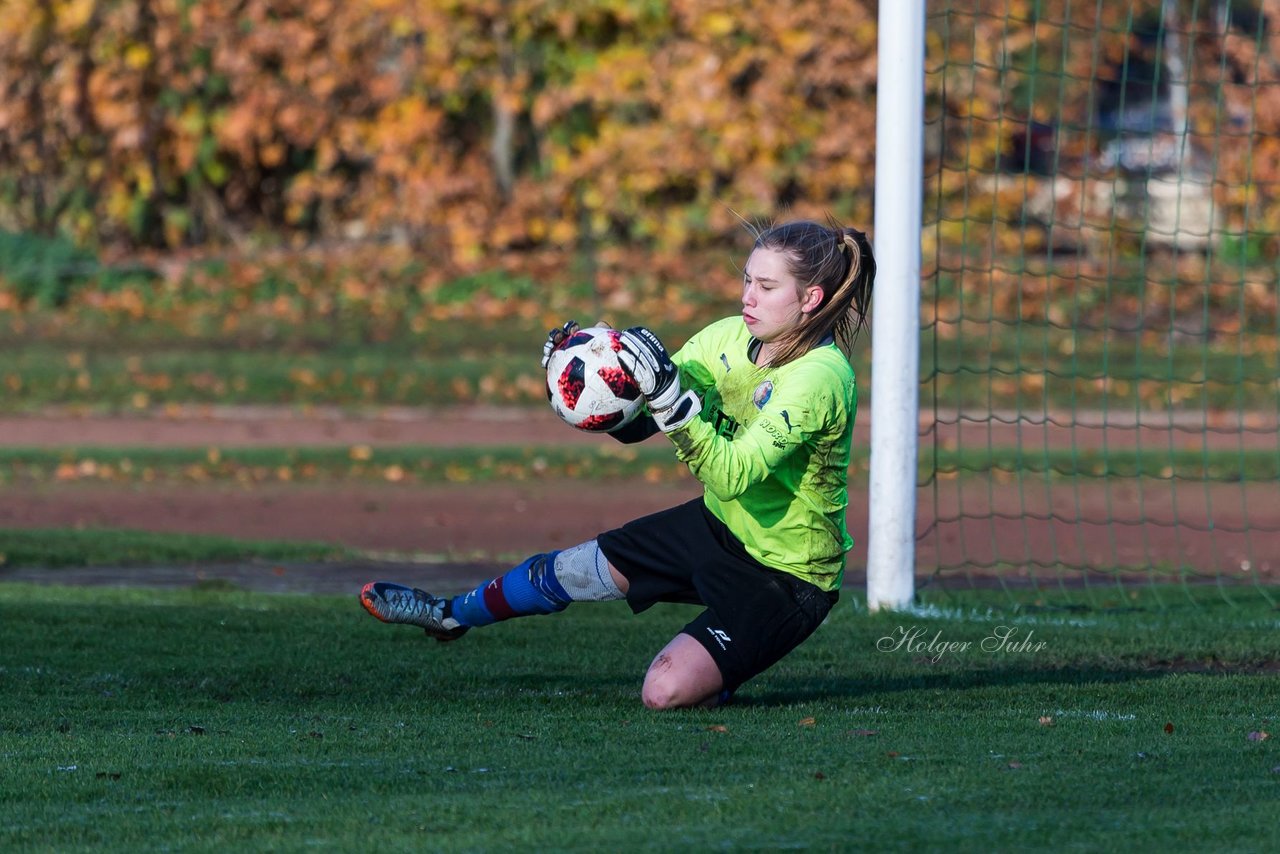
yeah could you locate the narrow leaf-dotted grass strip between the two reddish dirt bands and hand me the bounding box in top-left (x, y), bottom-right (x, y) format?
top-left (10, 443), bottom-right (1280, 488)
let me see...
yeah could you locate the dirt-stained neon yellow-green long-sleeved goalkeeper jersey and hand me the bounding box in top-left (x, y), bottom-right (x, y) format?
top-left (668, 316), bottom-right (858, 590)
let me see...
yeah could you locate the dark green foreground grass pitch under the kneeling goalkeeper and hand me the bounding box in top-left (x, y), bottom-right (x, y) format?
top-left (0, 581), bottom-right (1280, 851)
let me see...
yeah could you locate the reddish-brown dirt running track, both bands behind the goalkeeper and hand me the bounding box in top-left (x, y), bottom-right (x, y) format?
top-left (0, 408), bottom-right (1280, 592)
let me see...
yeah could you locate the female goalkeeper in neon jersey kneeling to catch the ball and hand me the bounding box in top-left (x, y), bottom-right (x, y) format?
top-left (360, 222), bottom-right (876, 709)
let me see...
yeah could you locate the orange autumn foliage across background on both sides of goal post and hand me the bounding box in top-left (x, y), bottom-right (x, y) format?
top-left (0, 0), bottom-right (1280, 277)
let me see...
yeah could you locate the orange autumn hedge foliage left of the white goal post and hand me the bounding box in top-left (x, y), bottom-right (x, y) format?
top-left (0, 0), bottom-right (876, 269)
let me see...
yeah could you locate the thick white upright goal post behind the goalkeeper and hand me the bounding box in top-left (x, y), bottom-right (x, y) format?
top-left (867, 0), bottom-right (925, 611)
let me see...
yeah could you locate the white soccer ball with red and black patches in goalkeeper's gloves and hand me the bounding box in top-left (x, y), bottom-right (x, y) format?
top-left (547, 326), bottom-right (644, 433)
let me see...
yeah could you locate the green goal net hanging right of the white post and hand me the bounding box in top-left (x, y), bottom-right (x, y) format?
top-left (916, 0), bottom-right (1280, 598)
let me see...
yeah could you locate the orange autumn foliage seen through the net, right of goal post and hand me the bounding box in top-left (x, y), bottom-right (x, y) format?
top-left (927, 0), bottom-right (1280, 260)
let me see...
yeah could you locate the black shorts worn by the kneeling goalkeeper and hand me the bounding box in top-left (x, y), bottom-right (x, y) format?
top-left (596, 498), bottom-right (840, 690)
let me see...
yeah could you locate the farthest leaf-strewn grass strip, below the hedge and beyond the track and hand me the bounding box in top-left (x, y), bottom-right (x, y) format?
top-left (0, 330), bottom-right (1280, 414)
